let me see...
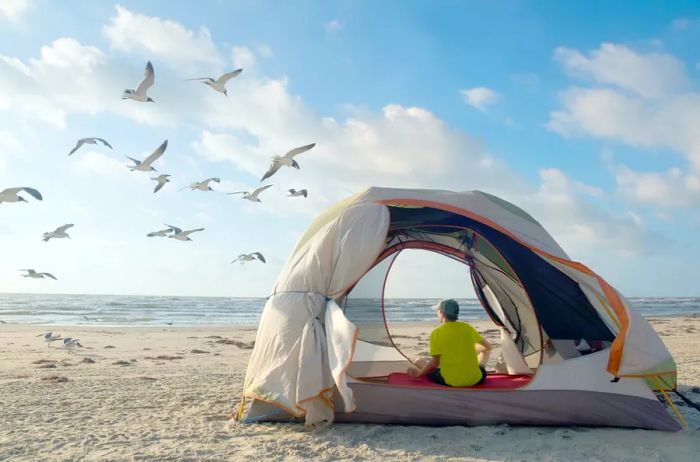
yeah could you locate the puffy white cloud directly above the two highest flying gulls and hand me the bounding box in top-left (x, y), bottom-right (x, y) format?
top-left (103, 5), bottom-right (222, 66)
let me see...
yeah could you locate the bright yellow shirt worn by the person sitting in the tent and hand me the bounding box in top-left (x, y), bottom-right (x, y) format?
top-left (430, 321), bottom-right (482, 387)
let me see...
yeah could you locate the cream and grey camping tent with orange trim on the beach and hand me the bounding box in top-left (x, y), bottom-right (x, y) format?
top-left (239, 188), bottom-right (680, 430)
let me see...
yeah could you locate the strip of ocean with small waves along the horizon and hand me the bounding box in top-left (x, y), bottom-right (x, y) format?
top-left (0, 293), bottom-right (700, 327)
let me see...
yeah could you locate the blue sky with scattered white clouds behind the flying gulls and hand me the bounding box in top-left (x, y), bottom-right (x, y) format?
top-left (0, 0), bottom-right (700, 297)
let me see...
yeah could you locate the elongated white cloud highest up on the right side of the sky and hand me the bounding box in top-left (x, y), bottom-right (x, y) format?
top-left (554, 43), bottom-right (689, 98)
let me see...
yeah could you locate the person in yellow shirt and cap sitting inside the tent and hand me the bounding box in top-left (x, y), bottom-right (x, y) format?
top-left (408, 299), bottom-right (492, 387)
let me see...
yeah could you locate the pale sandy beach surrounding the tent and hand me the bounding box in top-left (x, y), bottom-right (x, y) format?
top-left (0, 317), bottom-right (700, 461)
